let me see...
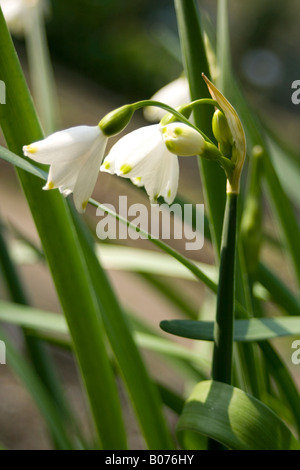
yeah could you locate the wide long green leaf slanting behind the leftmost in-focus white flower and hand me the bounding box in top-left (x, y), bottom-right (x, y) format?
top-left (0, 11), bottom-right (127, 449)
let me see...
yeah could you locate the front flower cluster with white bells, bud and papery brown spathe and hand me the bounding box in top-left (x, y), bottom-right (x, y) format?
top-left (23, 78), bottom-right (244, 213)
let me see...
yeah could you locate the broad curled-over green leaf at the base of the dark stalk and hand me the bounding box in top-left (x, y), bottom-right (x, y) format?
top-left (177, 380), bottom-right (300, 450)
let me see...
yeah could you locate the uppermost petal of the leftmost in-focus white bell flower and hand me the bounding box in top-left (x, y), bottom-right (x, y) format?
top-left (23, 126), bottom-right (102, 165)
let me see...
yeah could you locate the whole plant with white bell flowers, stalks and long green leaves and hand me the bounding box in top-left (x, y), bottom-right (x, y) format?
top-left (0, 0), bottom-right (300, 450)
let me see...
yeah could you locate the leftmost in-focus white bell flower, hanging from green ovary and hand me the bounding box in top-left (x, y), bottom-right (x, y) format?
top-left (23, 126), bottom-right (108, 213)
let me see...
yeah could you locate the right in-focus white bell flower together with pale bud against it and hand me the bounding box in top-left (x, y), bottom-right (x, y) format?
top-left (100, 122), bottom-right (203, 204)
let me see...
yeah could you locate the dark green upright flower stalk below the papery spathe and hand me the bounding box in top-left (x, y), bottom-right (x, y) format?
top-left (212, 193), bottom-right (237, 384)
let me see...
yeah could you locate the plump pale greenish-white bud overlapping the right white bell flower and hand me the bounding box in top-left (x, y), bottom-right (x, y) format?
top-left (161, 122), bottom-right (205, 157)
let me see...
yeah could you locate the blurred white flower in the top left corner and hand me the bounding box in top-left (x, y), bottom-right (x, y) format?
top-left (0, 0), bottom-right (48, 36)
